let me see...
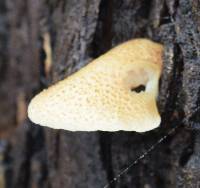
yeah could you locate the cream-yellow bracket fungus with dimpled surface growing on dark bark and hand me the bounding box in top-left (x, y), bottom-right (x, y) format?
top-left (28, 39), bottom-right (163, 132)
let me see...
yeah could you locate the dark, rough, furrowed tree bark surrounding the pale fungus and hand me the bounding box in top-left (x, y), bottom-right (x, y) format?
top-left (0, 0), bottom-right (200, 188)
